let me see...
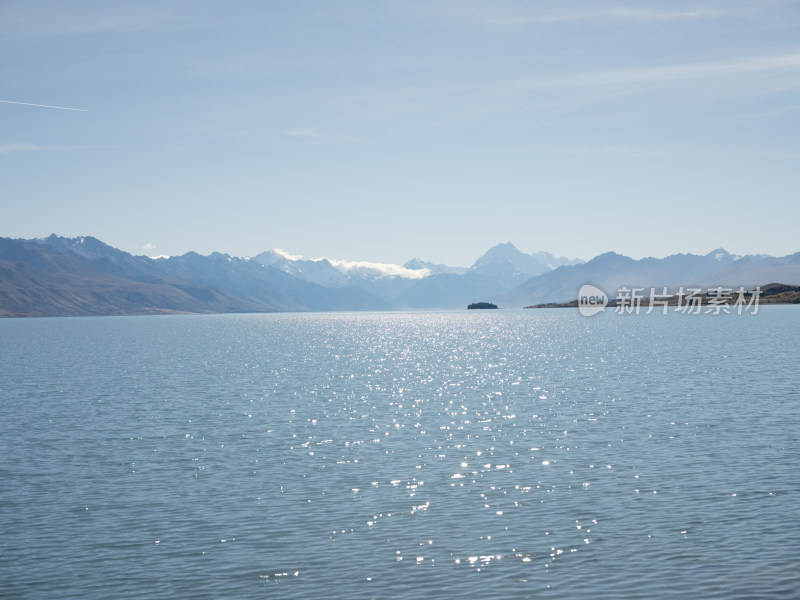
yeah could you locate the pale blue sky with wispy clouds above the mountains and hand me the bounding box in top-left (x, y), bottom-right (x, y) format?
top-left (0, 0), bottom-right (800, 266)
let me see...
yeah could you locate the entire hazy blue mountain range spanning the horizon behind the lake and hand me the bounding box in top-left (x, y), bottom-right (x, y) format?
top-left (0, 234), bottom-right (800, 317)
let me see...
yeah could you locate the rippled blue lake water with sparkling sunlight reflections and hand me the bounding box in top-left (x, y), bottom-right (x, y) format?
top-left (0, 306), bottom-right (800, 599)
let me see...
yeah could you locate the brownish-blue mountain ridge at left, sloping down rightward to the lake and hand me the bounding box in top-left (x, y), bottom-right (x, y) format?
top-left (0, 235), bottom-right (389, 317)
